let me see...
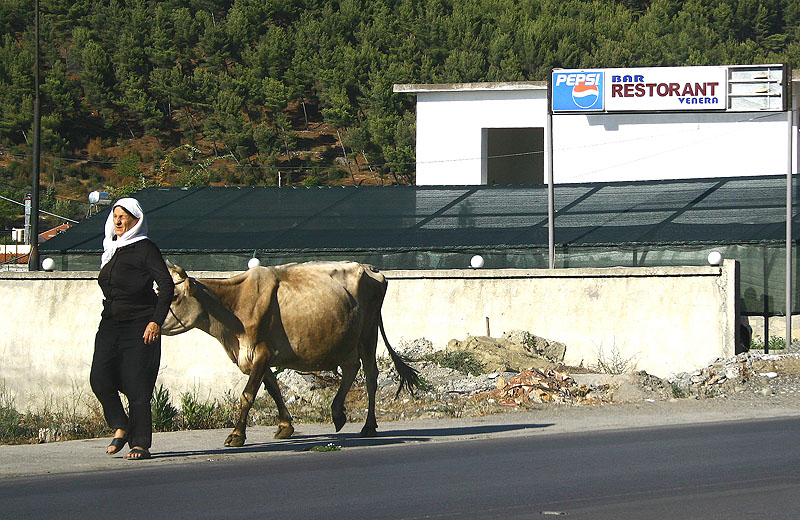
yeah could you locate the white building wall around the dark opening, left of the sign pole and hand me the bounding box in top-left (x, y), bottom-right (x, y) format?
top-left (417, 88), bottom-right (547, 186)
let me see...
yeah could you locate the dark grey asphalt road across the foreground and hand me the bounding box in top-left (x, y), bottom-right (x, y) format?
top-left (0, 408), bottom-right (800, 520)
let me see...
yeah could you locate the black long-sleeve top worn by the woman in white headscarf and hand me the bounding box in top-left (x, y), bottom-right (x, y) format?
top-left (97, 239), bottom-right (175, 327)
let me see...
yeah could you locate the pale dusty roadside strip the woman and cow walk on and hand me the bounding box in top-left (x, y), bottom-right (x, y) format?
top-left (0, 398), bottom-right (800, 478)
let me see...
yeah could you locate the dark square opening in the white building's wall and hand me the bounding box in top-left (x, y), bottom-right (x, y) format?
top-left (481, 128), bottom-right (544, 184)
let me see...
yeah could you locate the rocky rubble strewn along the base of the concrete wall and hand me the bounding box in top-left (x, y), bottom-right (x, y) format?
top-left (278, 331), bottom-right (800, 428)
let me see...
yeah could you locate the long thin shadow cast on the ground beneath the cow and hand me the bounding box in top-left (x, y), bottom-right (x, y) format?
top-left (153, 424), bottom-right (552, 459)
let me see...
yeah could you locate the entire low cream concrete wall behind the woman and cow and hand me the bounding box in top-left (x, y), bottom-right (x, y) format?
top-left (0, 260), bottom-right (737, 409)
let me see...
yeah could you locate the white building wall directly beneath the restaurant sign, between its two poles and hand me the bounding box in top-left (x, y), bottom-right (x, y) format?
top-left (553, 112), bottom-right (796, 183)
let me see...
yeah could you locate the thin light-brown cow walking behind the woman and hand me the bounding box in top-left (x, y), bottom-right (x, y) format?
top-left (162, 262), bottom-right (419, 446)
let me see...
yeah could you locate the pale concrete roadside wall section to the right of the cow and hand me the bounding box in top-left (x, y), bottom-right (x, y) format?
top-left (383, 260), bottom-right (738, 377)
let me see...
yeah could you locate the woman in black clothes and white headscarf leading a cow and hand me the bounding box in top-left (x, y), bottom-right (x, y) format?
top-left (89, 198), bottom-right (174, 460)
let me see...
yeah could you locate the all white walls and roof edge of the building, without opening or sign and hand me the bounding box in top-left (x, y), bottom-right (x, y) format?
top-left (404, 81), bottom-right (800, 185)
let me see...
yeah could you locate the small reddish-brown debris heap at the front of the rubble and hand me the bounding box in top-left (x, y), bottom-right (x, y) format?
top-left (486, 368), bottom-right (610, 406)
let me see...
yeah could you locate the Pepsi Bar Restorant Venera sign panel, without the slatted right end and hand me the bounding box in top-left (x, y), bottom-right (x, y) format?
top-left (551, 67), bottom-right (728, 112)
